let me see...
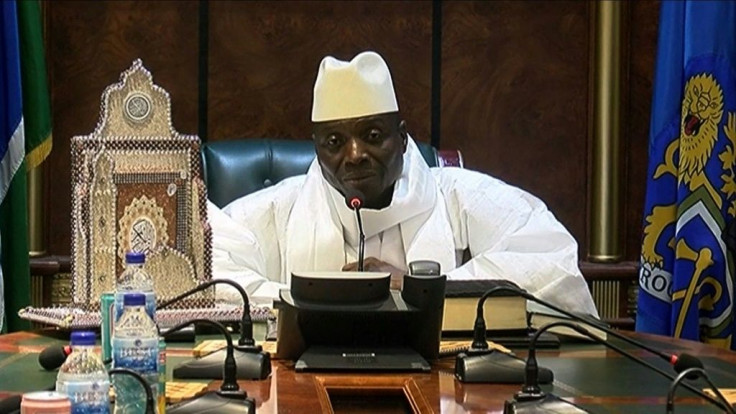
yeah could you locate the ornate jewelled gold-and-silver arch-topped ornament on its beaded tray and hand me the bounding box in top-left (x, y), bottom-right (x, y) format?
top-left (19, 60), bottom-right (241, 328)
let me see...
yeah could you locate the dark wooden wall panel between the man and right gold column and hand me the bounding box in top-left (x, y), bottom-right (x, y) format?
top-left (441, 1), bottom-right (590, 251)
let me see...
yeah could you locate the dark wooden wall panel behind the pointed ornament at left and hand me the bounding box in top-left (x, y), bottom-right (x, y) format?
top-left (44, 1), bottom-right (198, 255)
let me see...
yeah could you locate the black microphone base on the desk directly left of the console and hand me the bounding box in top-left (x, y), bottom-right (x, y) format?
top-left (174, 349), bottom-right (271, 380)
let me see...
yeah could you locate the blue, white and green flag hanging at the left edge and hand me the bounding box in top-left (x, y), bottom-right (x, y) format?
top-left (0, 0), bottom-right (51, 332)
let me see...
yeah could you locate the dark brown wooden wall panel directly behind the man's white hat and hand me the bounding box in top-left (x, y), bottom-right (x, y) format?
top-left (208, 1), bottom-right (432, 141)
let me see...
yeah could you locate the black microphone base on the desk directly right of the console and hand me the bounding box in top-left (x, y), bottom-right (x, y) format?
top-left (455, 351), bottom-right (554, 384)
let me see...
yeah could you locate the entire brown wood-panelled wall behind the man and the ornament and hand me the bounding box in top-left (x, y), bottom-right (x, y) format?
top-left (43, 1), bottom-right (659, 261)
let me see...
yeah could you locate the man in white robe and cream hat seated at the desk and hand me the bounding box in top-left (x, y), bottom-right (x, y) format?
top-left (209, 52), bottom-right (597, 315)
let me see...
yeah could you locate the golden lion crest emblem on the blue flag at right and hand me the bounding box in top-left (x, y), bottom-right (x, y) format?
top-left (639, 73), bottom-right (736, 341)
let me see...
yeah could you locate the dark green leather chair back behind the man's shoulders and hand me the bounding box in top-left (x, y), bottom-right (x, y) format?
top-left (202, 138), bottom-right (462, 208)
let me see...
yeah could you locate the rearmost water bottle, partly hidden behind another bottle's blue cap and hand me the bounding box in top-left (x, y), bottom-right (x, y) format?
top-left (115, 252), bottom-right (156, 322)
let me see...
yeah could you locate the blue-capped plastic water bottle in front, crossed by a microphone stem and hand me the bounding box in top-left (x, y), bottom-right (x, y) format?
top-left (112, 293), bottom-right (159, 414)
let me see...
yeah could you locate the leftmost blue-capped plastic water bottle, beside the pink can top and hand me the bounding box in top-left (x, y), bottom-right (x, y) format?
top-left (56, 331), bottom-right (110, 414)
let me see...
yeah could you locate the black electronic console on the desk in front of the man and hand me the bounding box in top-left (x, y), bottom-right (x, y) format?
top-left (276, 272), bottom-right (447, 372)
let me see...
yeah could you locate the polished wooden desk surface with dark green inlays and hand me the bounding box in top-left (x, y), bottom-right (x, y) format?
top-left (0, 331), bottom-right (736, 413)
